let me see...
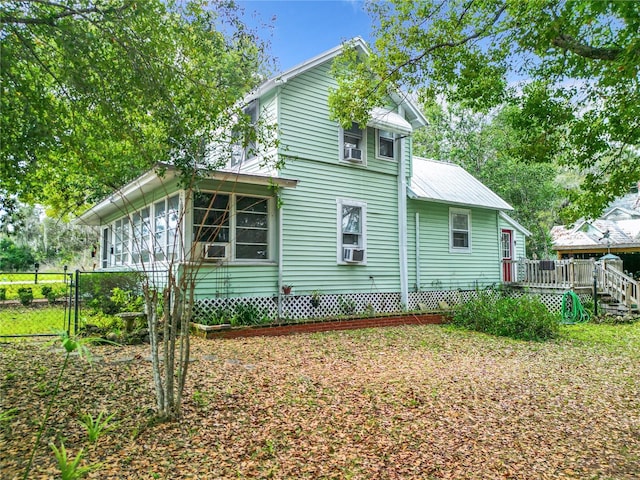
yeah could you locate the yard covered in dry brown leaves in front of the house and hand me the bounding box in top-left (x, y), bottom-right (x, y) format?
top-left (0, 324), bottom-right (640, 479)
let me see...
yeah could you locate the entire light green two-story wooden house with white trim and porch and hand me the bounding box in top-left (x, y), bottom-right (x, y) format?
top-left (76, 39), bottom-right (528, 317)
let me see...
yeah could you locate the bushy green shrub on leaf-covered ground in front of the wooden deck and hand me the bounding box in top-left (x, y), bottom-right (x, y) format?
top-left (452, 291), bottom-right (560, 340)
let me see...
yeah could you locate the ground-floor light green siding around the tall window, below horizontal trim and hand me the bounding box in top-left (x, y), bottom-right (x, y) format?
top-left (281, 160), bottom-right (400, 294)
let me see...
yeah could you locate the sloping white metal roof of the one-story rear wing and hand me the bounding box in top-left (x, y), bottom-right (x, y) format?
top-left (409, 157), bottom-right (513, 210)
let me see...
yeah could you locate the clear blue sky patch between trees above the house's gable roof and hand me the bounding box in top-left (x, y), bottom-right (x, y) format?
top-left (238, 0), bottom-right (371, 71)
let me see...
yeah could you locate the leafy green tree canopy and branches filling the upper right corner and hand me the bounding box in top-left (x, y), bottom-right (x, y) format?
top-left (331, 0), bottom-right (640, 217)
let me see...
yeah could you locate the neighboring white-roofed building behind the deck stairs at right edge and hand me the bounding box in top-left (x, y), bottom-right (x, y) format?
top-left (551, 188), bottom-right (640, 274)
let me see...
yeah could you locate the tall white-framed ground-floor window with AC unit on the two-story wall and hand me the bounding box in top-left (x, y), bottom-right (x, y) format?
top-left (337, 200), bottom-right (367, 264)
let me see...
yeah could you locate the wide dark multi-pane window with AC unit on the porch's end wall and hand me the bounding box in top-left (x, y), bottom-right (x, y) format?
top-left (193, 193), bottom-right (271, 260)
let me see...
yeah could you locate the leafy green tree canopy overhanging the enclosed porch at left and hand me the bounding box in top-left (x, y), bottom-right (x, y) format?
top-left (0, 0), bottom-right (263, 213)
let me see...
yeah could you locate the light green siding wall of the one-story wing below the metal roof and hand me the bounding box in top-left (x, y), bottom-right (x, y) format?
top-left (407, 200), bottom-right (500, 290)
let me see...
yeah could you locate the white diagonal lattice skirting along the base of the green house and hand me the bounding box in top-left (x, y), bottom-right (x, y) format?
top-left (194, 290), bottom-right (591, 321)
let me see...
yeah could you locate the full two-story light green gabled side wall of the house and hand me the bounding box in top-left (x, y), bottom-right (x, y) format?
top-left (279, 65), bottom-right (408, 295)
